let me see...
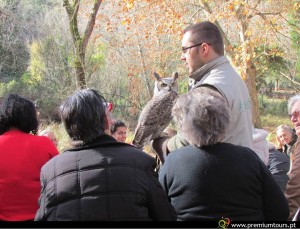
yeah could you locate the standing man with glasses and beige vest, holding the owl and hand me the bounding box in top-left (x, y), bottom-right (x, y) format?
top-left (152, 21), bottom-right (253, 163)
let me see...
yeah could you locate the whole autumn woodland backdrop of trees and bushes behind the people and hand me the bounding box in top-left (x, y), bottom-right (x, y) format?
top-left (0, 0), bottom-right (300, 152)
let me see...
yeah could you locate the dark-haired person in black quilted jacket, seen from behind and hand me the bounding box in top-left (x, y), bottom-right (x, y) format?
top-left (35, 89), bottom-right (176, 221)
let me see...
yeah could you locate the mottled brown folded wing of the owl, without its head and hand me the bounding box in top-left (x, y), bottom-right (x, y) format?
top-left (132, 91), bottom-right (178, 148)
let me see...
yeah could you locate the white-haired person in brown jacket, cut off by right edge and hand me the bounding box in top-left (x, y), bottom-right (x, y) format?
top-left (285, 95), bottom-right (300, 220)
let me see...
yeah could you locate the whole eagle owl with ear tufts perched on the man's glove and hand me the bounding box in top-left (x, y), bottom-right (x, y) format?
top-left (132, 72), bottom-right (178, 149)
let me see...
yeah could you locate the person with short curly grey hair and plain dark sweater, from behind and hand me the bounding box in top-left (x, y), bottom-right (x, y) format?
top-left (159, 87), bottom-right (288, 221)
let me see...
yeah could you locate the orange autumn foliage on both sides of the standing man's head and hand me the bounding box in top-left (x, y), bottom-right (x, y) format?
top-left (78, 0), bottom-right (300, 123)
